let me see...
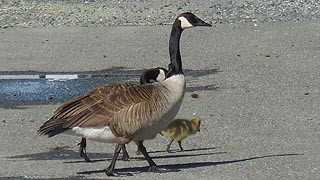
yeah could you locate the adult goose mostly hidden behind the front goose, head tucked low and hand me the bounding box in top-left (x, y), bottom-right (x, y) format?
top-left (78, 67), bottom-right (168, 162)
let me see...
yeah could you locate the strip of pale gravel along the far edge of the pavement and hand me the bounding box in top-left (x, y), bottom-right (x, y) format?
top-left (0, 0), bottom-right (320, 28)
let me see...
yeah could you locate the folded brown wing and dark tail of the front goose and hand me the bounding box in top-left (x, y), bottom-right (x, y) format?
top-left (39, 83), bottom-right (154, 136)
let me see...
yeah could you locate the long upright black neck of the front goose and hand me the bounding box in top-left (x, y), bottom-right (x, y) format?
top-left (166, 20), bottom-right (183, 77)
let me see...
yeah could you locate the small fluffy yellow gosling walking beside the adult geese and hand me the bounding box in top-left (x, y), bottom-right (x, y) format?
top-left (161, 116), bottom-right (201, 152)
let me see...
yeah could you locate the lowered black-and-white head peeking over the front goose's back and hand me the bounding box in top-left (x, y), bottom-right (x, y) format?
top-left (140, 67), bottom-right (168, 84)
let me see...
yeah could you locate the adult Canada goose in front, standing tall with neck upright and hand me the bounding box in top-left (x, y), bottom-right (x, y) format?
top-left (39, 12), bottom-right (211, 176)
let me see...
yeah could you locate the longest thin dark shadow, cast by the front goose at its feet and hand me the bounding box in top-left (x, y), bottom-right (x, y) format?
top-left (77, 153), bottom-right (304, 174)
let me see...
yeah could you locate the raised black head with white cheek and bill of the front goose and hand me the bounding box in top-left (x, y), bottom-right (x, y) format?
top-left (175, 12), bottom-right (212, 29)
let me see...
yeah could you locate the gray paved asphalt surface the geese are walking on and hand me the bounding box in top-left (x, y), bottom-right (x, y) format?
top-left (0, 6), bottom-right (320, 180)
